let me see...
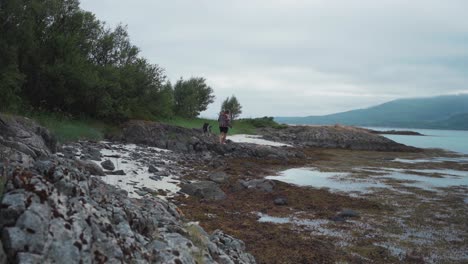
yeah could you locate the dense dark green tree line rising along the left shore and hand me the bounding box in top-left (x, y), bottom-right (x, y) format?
top-left (0, 0), bottom-right (214, 121)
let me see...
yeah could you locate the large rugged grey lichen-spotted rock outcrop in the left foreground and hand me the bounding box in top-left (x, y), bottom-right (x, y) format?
top-left (0, 158), bottom-right (255, 264)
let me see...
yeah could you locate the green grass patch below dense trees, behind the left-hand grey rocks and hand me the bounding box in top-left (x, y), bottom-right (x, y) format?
top-left (28, 113), bottom-right (119, 143)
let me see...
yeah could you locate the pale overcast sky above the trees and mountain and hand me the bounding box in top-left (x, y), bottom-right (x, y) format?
top-left (81, 0), bottom-right (468, 117)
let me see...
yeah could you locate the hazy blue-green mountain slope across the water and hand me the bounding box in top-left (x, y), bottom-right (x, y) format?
top-left (275, 94), bottom-right (468, 130)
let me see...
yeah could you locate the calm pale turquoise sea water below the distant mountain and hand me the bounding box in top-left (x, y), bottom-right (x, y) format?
top-left (369, 127), bottom-right (468, 154)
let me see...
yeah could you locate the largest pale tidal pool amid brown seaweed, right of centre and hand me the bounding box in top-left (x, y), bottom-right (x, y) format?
top-left (266, 168), bottom-right (388, 192)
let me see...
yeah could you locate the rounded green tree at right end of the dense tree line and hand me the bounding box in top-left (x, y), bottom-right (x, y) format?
top-left (174, 78), bottom-right (214, 118)
